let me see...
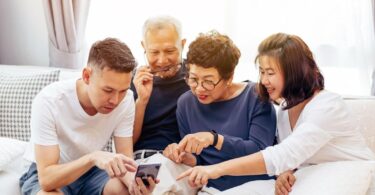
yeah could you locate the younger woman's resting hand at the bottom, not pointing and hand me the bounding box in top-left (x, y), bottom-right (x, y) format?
top-left (275, 171), bottom-right (296, 195)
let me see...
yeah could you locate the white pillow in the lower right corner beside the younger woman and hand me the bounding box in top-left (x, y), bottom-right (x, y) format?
top-left (290, 161), bottom-right (375, 195)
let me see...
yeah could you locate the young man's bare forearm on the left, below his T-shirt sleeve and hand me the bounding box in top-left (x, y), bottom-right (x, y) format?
top-left (38, 155), bottom-right (94, 191)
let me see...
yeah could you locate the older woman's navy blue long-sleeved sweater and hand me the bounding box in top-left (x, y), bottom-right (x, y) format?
top-left (176, 83), bottom-right (276, 191)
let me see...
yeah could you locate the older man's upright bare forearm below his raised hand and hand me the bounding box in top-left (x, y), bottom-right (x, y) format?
top-left (133, 99), bottom-right (147, 144)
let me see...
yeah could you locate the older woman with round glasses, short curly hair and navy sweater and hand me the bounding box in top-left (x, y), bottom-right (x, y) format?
top-left (164, 32), bottom-right (276, 194)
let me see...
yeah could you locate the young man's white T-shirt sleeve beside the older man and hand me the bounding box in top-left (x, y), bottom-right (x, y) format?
top-left (113, 90), bottom-right (135, 137)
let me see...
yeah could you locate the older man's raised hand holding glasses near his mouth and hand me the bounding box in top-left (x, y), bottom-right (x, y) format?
top-left (133, 66), bottom-right (154, 103)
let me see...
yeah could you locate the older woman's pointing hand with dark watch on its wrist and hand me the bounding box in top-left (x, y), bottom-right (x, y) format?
top-left (178, 132), bottom-right (214, 155)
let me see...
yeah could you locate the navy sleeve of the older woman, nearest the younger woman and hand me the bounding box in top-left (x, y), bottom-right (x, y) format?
top-left (221, 101), bottom-right (276, 158)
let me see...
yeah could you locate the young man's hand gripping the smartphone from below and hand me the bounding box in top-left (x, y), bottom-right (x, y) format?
top-left (129, 177), bottom-right (160, 195)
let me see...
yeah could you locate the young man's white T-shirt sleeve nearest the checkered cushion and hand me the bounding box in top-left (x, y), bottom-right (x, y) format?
top-left (30, 94), bottom-right (58, 146)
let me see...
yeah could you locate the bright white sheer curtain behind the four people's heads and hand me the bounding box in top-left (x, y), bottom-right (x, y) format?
top-left (87, 0), bottom-right (375, 95)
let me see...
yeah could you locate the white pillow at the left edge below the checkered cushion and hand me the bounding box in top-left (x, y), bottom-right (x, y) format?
top-left (0, 137), bottom-right (27, 171)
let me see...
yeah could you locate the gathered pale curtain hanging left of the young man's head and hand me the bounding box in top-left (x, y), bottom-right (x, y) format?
top-left (43, 0), bottom-right (90, 68)
